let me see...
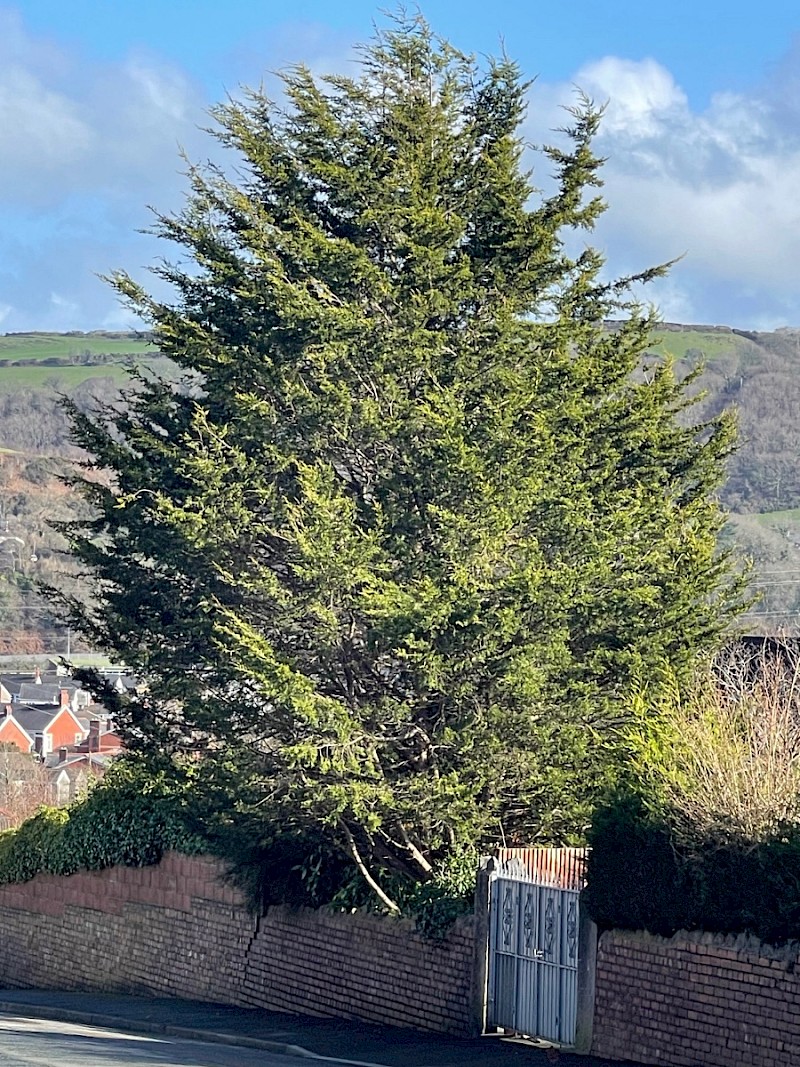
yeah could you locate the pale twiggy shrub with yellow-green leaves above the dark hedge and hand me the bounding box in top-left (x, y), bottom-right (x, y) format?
top-left (631, 642), bottom-right (800, 845)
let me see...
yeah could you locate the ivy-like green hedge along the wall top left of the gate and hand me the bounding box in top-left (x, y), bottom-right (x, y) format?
top-left (0, 760), bottom-right (474, 940)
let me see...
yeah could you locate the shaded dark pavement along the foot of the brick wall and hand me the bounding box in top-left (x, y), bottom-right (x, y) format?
top-left (0, 989), bottom-right (646, 1067)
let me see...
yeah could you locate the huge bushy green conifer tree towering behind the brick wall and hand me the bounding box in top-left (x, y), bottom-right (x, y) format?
top-left (59, 12), bottom-right (739, 902)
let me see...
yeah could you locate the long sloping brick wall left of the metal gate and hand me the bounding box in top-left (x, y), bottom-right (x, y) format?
top-left (0, 854), bottom-right (473, 1034)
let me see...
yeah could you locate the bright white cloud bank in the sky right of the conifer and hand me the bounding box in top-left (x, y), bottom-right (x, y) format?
top-left (529, 57), bottom-right (800, 325)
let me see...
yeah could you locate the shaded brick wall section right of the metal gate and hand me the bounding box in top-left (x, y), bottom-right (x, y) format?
top-left (592, 930), bottom-right (800, 1067)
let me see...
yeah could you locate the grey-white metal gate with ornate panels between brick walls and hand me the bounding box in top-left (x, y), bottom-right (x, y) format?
top-left (486, 849), bottom-right (583, 1046)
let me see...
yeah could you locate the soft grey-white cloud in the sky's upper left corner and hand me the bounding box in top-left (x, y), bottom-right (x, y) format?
top-left (0, 11), bottom-right (205, 209)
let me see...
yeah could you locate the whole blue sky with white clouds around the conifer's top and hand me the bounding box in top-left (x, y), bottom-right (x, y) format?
top-left (0, 0), bottom-right (800, 332)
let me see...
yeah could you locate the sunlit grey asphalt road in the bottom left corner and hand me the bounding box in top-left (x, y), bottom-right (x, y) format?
top-left (0, 1015), bottom-right (356, 1067)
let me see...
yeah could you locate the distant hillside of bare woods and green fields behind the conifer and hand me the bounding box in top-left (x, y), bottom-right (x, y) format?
top-left (0, 327), bottom-right (800, 654)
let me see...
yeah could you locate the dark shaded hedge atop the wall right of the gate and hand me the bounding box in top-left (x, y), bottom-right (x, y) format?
top-left (583, 793), bottom-right (800, 944)
